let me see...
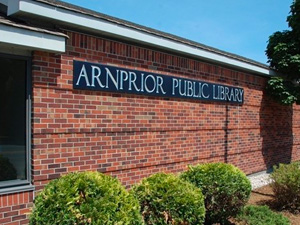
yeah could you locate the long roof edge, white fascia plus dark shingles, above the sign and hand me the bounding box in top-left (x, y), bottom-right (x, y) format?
top-left (8, 0), bottom-right (277, 76)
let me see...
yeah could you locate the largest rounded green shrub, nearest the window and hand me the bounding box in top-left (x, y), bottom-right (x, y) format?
top-left (30, 172), bottom-right (143, 225)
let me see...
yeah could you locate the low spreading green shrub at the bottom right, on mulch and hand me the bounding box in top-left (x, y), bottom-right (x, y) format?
top-left (237, 205), bottom-right (291, 225)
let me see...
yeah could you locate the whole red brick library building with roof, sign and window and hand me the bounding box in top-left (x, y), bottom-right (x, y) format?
top-left (0, 0), bottom-right (300, 224)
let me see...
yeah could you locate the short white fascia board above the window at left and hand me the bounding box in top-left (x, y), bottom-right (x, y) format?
top-left (0, 24), bottom-right (66, 52)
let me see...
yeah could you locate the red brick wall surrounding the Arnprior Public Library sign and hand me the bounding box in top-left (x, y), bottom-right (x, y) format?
top-left (0, 32), bottom-right (300, 224)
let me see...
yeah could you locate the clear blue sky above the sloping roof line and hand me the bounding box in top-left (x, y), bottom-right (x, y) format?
top-left (64, 0), bottom-right (293, 64)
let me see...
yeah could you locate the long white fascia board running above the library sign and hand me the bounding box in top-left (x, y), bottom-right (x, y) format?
top-left (8, 0), bottom-right (275, 76)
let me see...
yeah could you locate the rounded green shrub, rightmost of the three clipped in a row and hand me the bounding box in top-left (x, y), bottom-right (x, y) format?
top-left (181, 163), bottom-right (251, 224)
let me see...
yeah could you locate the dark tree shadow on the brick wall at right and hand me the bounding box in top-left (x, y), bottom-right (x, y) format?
top-left (260, 93), bottom-right (293, 169)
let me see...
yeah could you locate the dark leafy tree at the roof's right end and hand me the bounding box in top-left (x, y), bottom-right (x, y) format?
top-left (266, 0), bottom-right (300, 105)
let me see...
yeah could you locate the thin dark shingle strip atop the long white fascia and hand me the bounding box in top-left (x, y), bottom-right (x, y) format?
top-left (35, 0), bottom-right (269, 69)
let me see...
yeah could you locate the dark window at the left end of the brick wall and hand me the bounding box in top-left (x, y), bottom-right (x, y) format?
top-left (0, 55), bottom-right (30, 190)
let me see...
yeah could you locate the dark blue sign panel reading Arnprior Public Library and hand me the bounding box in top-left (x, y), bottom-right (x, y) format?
top-left (73, 61), bottom-right (244, 104)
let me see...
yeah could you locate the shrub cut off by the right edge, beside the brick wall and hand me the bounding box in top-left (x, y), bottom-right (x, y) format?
top-left (270, 162), bottom-right (300, 211)
